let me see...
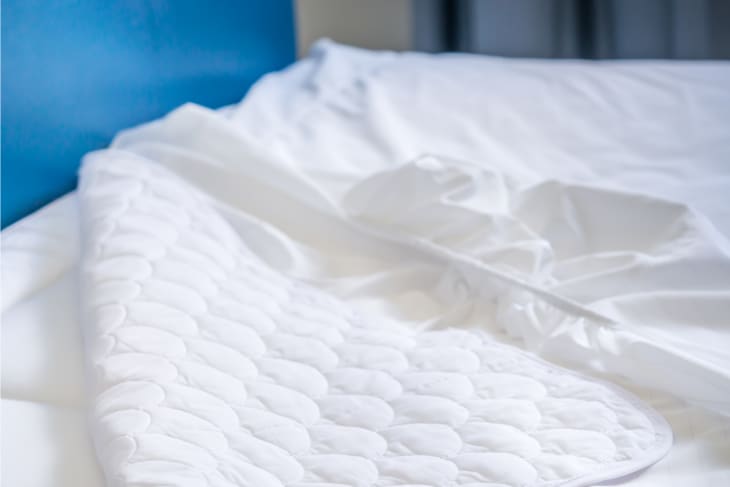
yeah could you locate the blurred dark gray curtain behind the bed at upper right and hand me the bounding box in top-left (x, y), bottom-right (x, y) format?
top-left (413, 0), bottom-right (730, 59)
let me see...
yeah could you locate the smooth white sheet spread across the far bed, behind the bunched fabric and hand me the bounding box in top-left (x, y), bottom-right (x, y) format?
top-left (230, 41), bottom-right (730, 236)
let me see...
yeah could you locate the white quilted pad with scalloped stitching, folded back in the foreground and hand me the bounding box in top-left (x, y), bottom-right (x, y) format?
top-left (80, 153), bottom-right (671, 487)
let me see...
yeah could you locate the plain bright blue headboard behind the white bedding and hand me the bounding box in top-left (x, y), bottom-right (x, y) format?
top-left (2, 0), bottom-right (295, 227)
